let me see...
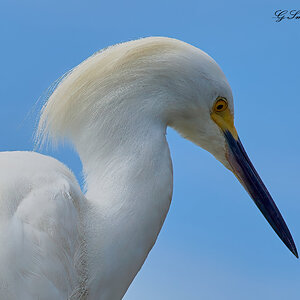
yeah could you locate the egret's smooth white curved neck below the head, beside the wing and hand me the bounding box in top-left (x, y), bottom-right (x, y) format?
top-left (77, 115), bottom-right (173, 300)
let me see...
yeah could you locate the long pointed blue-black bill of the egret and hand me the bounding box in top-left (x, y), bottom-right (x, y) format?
top-left (224, 130), bottom-right (298, 258)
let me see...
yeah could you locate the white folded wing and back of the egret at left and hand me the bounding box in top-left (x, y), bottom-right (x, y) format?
top-left (0, 152), bottom-right (85, 300)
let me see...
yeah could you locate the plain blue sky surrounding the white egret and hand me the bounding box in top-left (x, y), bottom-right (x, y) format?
top-left (0, 0), bottom-right (300, 300)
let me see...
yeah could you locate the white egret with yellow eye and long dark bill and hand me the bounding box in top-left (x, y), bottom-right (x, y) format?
top-left (0, 37), bottom-right (298, 300)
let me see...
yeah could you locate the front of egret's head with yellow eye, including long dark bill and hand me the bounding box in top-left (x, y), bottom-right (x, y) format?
top-left (148, 37), bottom-right (298, 257)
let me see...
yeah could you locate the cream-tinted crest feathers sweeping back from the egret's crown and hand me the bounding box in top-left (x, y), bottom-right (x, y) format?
top-left (36, 37), bottom-right (191, 143)
